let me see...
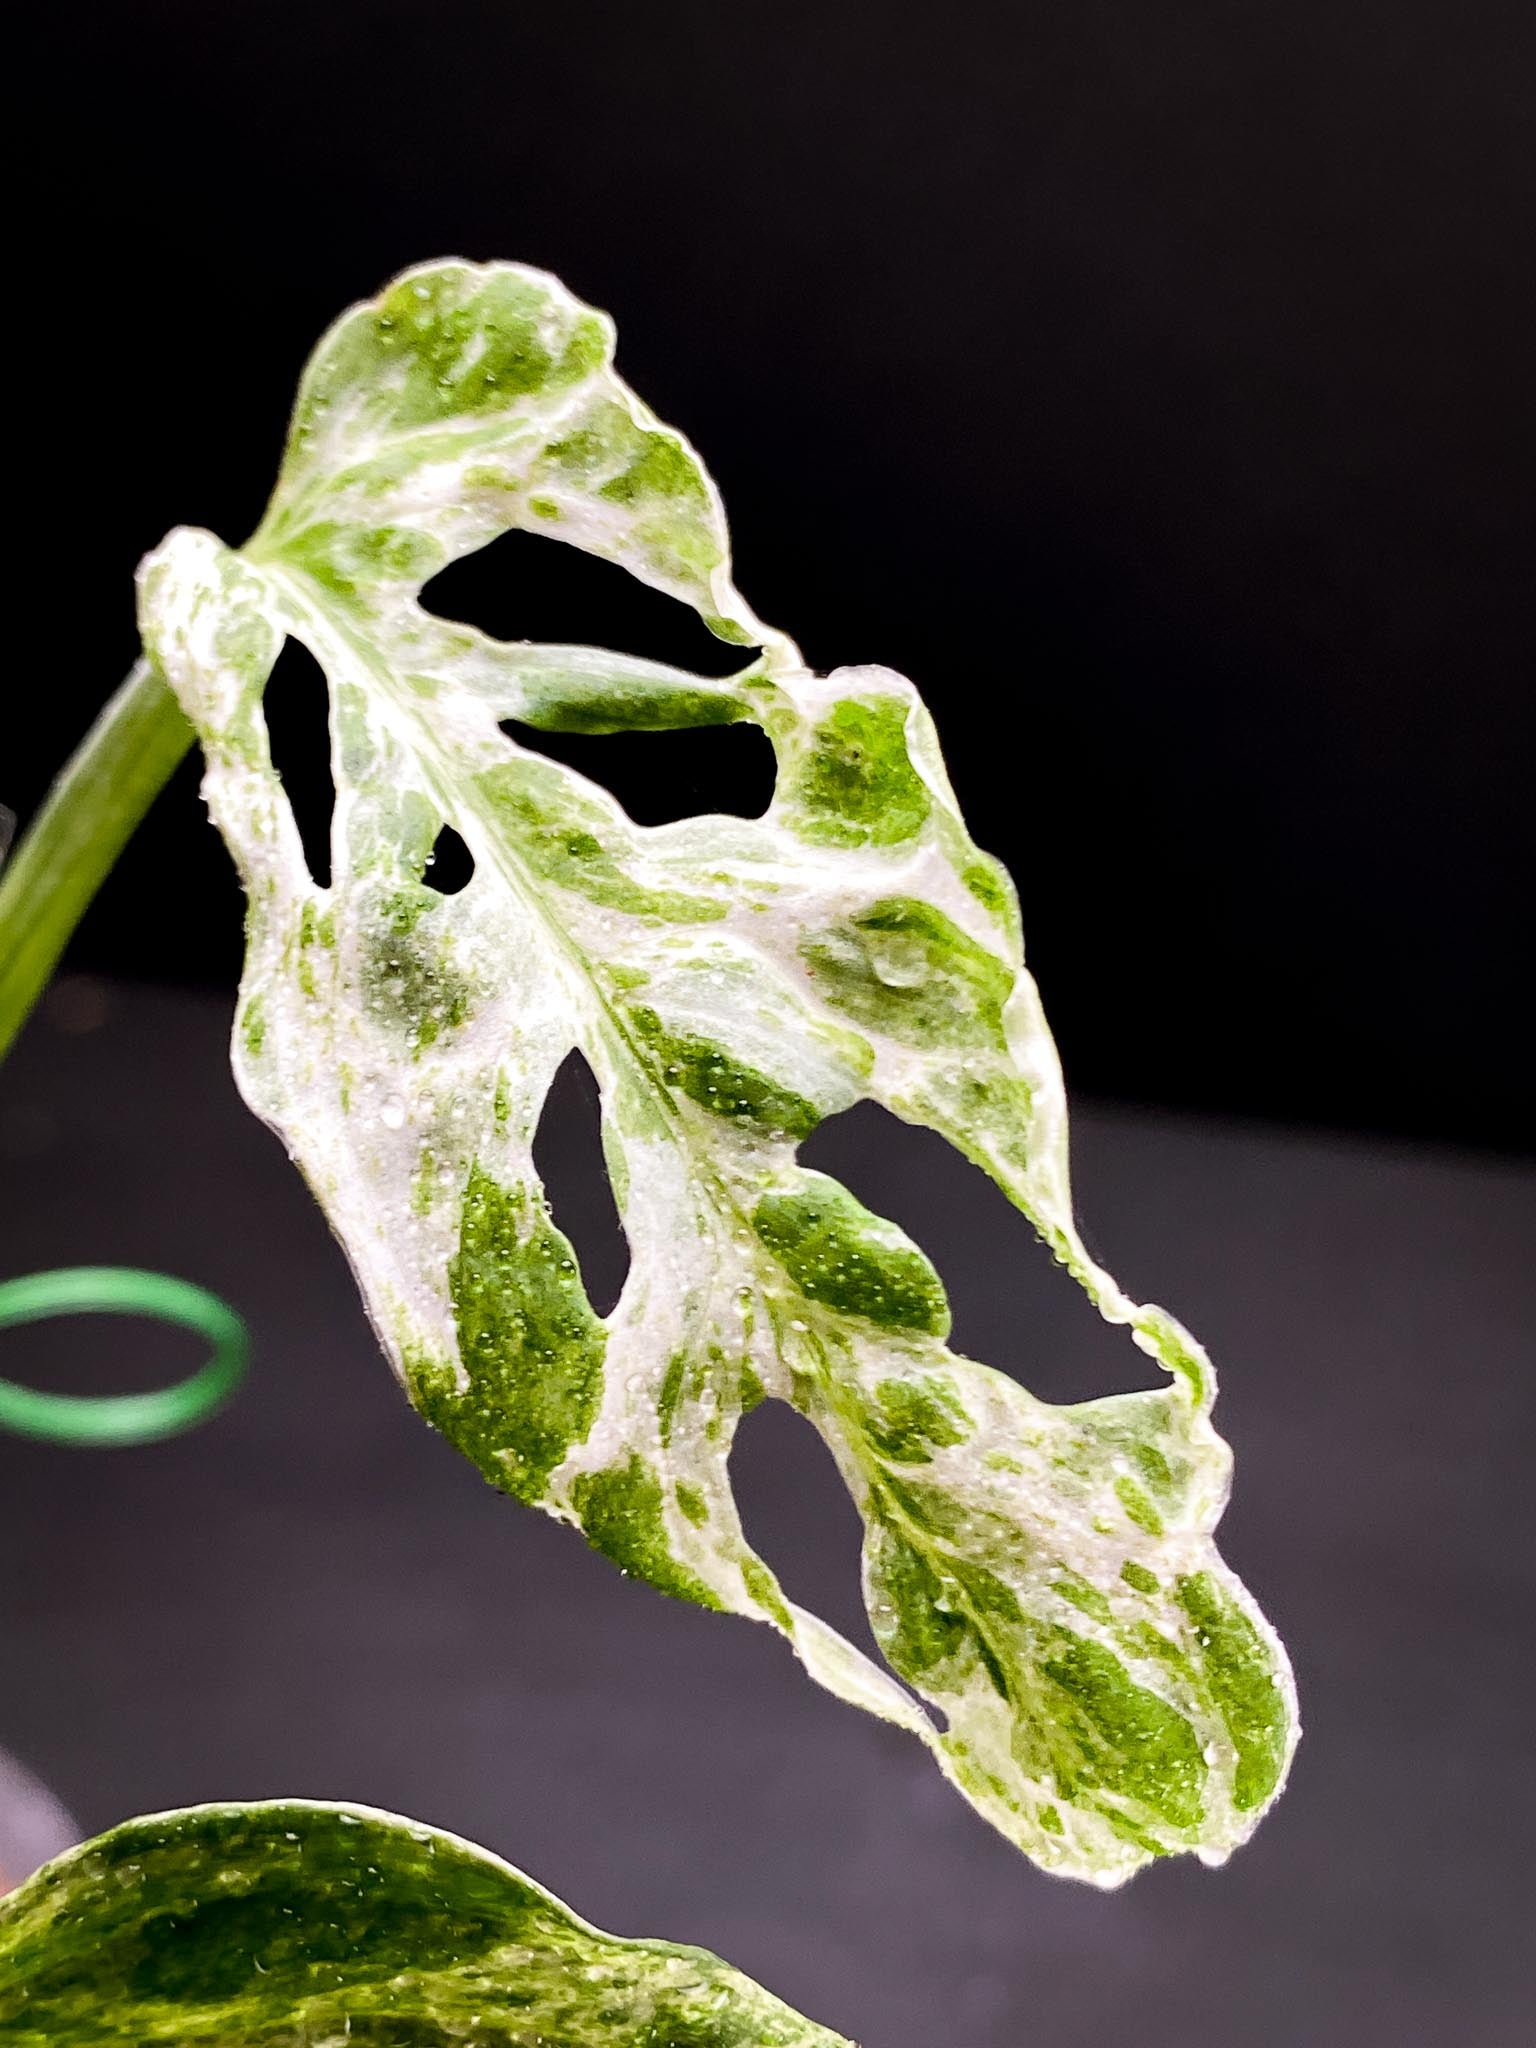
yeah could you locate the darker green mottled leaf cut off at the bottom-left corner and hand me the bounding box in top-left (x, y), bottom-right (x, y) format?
top-left (0, 1800), bottom-right (850, 2048)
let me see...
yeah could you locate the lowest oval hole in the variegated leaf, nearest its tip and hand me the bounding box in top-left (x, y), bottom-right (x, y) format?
top-left (731, 1401), bottom-right (885, 1663)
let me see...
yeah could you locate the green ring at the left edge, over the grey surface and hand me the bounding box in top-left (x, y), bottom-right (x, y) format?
top-left (0, 1266), bottom-right (250, 1444)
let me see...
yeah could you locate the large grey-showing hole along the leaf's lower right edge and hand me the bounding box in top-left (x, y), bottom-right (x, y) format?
top-left (799, 1102), bottom-right (1167, 1403)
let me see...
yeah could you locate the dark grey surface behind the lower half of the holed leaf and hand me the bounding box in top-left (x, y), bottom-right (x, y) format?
top-left (0, 987), bottom-right (1536, 2048)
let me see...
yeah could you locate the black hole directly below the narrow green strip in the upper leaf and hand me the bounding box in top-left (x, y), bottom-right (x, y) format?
top-left (502, 719), bottom-right (776, 825)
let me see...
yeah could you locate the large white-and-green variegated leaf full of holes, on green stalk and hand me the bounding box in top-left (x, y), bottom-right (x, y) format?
top-left (141, 262), bottom-right (1294, 1884)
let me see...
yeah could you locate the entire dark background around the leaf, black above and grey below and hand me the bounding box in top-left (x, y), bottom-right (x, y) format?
top-left (0, 12), bottom-right (1536, 2048)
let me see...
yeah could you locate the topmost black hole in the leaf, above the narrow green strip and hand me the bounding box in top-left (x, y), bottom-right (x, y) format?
top-left (422, 530), bottom-right (752, 676)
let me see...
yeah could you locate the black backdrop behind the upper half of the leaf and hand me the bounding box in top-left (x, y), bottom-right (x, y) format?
top-left (12, 0), bottom-right (1536, 1145)
